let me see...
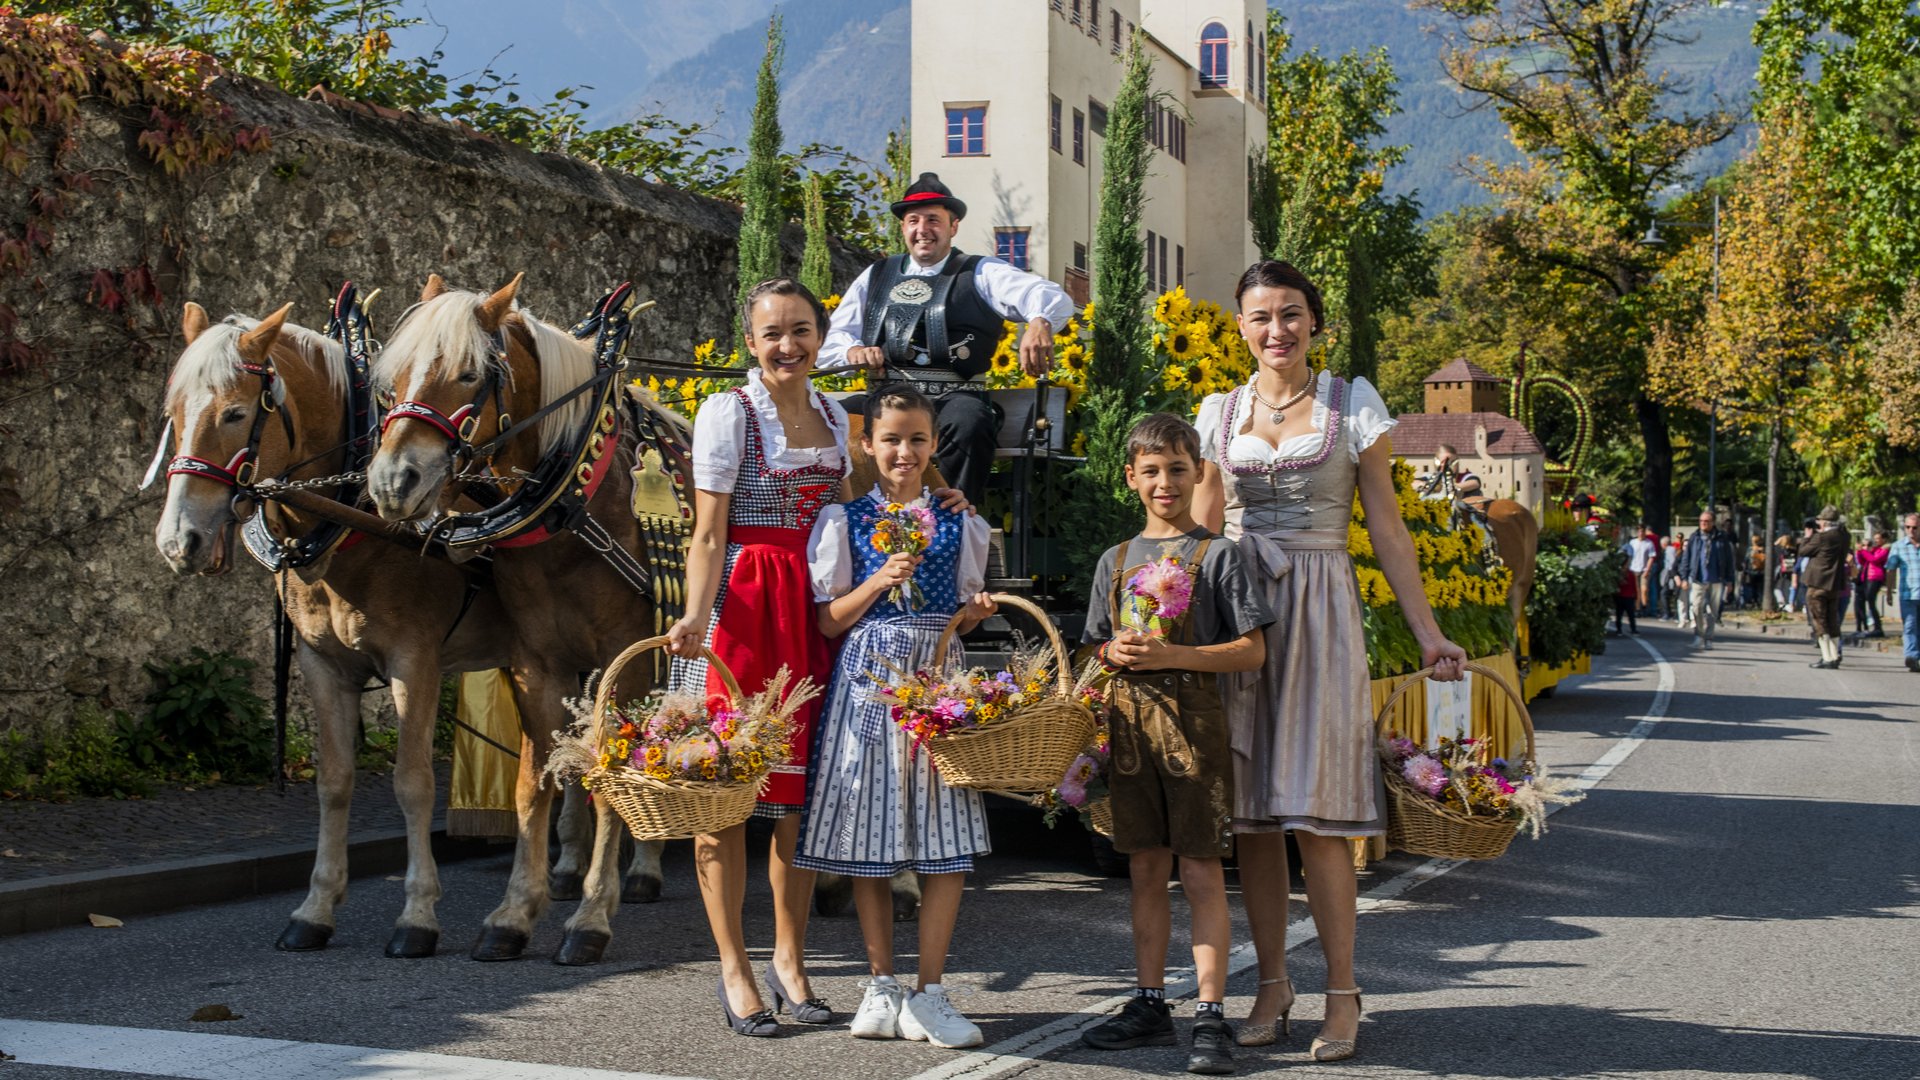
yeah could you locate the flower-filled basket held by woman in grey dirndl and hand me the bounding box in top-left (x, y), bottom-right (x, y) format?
top-left (1375, 663), bottom-right (1584, 859)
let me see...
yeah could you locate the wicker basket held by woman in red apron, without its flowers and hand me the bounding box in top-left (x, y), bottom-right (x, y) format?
top-left (588, 636), bottom-right (766, 840)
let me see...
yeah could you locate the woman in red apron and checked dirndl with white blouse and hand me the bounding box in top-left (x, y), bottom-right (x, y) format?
top-left (668, 279), bottom-right (849, 1036)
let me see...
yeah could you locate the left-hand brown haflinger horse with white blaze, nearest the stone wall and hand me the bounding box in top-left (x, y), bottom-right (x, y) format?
top-left (154, 304), bottom-right (509, 957)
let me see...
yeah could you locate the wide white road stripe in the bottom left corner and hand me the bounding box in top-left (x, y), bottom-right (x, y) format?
top-left (0, 1019), bottom-right (698, 1080)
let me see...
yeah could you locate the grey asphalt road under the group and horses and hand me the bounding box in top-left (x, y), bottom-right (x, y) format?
top-left (0, 628), bottom-right (1920, 1080)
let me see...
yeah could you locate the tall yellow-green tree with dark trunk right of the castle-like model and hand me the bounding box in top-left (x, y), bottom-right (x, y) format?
top-left (1415, 0), bottom-right (1734, 532)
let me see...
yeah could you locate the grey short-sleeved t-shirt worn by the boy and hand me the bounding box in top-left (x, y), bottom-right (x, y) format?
top-left (1083, 528), bottom-right (1273, 646)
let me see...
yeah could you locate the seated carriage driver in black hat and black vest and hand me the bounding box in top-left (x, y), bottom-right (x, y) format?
top-left (818, 173), bottom-right (1073, 498)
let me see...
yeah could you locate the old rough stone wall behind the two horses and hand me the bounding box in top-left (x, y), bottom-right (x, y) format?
top-left (0, 83), bottom-right (860, 728)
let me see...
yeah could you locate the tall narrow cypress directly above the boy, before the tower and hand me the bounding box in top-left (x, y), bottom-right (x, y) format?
top-left (1069, 38), bottom-right (1154, 586)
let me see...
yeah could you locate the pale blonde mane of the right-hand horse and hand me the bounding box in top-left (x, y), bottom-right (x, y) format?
top-left (374, 288), bottom-right (593, 454)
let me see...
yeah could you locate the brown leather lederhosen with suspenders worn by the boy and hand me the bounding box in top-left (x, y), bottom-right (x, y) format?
top-left (1108, 536), bottom-right (1233, 859)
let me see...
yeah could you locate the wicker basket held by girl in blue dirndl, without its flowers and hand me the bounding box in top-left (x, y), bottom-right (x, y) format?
top-left (927, 592), bottom-right (1094, 792)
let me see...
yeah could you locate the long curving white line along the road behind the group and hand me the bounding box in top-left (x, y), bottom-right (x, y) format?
top-left (908, 638), bottom-right (1674, 1080)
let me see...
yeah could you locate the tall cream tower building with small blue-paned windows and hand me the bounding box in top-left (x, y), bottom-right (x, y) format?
top-left (910, 0), bottom-right (1267, 304)
